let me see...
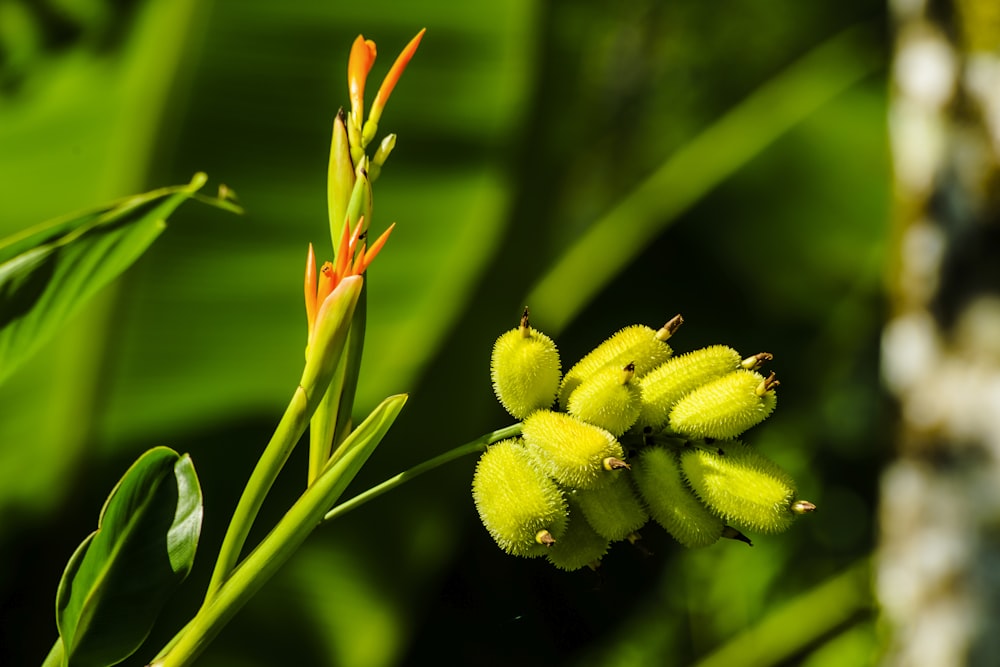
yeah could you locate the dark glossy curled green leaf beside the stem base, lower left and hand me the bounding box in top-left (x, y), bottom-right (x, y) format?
top-left (56, 447), bottom-right (203, 667)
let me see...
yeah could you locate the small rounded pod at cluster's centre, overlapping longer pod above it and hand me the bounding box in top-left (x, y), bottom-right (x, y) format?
top-left (566, 363), bottom-right (642, 437)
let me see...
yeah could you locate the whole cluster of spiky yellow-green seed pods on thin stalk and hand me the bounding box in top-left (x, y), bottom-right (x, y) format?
top-left (472, 309), bottom-right (815, 570)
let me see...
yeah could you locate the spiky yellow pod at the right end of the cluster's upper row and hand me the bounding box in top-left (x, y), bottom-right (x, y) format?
top-left (670, 369), bottom-right (778, 440)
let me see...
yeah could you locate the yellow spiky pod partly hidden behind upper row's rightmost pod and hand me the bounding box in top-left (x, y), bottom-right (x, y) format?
top-left (638, 345), bottom-right (741, 431)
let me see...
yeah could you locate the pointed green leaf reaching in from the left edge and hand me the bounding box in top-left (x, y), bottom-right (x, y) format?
top-left (0, 174), bottom-right (215, 381)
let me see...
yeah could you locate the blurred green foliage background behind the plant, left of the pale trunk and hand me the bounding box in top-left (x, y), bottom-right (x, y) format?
top-left (0, 0), bottom-right (890, 667)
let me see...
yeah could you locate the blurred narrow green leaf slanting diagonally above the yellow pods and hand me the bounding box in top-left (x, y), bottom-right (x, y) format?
top-left (524, 23), bottom-right (881, 332)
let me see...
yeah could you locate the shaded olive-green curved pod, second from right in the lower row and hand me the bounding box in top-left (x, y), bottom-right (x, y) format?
top-left (632, 446), bottom-right (723, 549)
